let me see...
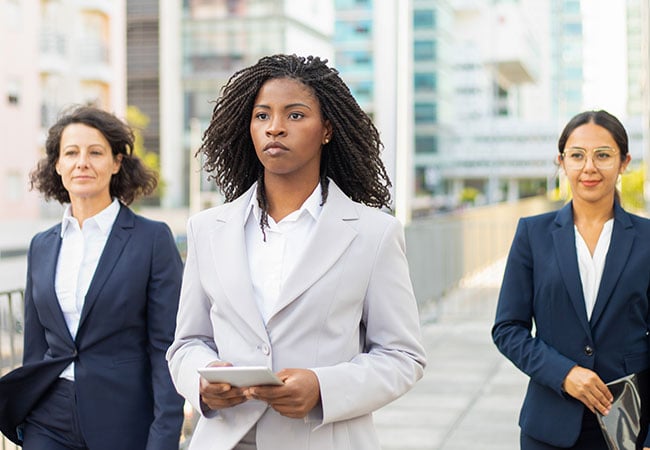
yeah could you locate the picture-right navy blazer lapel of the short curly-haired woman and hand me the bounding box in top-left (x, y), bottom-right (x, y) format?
top-left (77, 205), bottom-right (135, 335)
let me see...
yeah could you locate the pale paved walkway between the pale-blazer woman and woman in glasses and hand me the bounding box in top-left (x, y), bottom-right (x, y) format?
top-left (375, 262), bottom-right (527, 450)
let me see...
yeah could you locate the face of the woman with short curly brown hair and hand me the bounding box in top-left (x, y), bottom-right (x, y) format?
top-left (56, 123), bottom-right (122, 203)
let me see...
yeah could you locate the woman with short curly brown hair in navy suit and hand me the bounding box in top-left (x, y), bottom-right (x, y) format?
top-left (0, 107), bottom-right (183, 450)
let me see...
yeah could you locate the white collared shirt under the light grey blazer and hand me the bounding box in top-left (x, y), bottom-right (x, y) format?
top-left (244, 183), bottom-right (323, 323)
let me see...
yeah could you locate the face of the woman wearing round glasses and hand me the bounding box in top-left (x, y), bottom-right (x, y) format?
top-left (559, 123), bottom-right (630, 203)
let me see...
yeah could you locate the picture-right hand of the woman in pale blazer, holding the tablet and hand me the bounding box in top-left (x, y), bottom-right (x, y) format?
top-left (246, 369), bottom-right (320, 419)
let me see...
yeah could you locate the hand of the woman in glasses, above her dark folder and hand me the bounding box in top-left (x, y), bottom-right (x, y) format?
top-left (563, 366), bottom-right (614, 415)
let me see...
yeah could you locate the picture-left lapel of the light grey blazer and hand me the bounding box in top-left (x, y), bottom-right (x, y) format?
top-left (210, 185), bottom-right (268, 341)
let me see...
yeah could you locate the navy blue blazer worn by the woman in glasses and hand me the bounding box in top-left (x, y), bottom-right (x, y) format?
top-left (492, 203), bottom-right (650, 447)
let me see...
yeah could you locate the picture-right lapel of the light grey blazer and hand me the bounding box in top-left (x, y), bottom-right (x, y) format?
top-left (269, 180), bottom-right (359, 320)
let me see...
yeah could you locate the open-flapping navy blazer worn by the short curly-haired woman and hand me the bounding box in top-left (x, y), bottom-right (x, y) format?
top-left (0, 205), bottom-right (183, 450)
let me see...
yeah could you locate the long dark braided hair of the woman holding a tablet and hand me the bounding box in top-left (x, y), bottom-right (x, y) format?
top-left (197, 55), bottom-right (391, 215)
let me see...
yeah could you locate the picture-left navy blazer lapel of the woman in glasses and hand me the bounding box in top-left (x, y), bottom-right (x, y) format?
top-left (552, 202), bottom-right (591, 335)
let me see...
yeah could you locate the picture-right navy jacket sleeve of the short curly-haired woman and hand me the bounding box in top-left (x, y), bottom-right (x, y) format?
top-left (147, 224), bottom-right (183, 450)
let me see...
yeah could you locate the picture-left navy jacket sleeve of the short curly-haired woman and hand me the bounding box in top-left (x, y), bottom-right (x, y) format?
top-left (23, 234), bottom-right (48, 364)
